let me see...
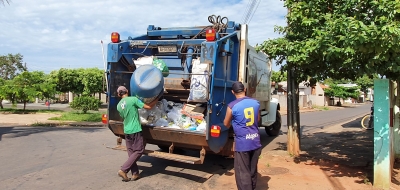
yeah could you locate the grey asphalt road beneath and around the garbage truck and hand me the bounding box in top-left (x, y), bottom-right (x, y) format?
top-left (0, 105), bottom-right (370, 190)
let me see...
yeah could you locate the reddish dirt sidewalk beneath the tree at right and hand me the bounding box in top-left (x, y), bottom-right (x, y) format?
top-left (205, 113), bottom-right (400, 190)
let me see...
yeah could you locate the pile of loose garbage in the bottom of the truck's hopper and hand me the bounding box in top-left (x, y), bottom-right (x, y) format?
top-left (139, 99), bottom-right (207, 132)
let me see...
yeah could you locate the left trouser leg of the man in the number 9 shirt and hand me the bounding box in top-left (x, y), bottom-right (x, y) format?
top-left (234, 151), bottom-right (253, 190)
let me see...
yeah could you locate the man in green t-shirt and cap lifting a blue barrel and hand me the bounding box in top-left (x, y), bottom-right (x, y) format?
top-left (117, 86), bottom-right (158, 182)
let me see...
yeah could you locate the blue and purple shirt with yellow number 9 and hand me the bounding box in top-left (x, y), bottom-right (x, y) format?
top-left (228, 97), bottom-right (261, 152)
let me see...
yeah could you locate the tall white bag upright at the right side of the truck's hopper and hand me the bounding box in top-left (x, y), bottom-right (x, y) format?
top-left (188, 58), bottom-right (209, 102)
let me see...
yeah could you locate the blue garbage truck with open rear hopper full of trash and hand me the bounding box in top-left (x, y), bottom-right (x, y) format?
top-left (103, 16), bottom-right (281, 164)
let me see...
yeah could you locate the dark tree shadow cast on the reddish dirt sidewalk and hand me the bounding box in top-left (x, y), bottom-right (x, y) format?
top-left (272, 118), bottom-right (374, 187)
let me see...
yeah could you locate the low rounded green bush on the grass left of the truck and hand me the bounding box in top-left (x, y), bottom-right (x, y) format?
top-left (70, 96), bottom-right (101, 113)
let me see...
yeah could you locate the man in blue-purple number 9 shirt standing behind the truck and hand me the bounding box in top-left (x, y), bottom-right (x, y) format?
top-left (224, 82), bottom-right (261, 190)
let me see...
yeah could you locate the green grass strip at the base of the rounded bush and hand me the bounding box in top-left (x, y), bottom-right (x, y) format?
top-left (49, 111), bottom-right (103, 122)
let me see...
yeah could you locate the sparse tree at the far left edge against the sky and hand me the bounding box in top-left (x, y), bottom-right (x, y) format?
top-left (0, 54), bottom-right (27, 109)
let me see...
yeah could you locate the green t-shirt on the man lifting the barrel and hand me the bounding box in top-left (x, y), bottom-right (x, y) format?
top-left (117, 97), bottom-right (144, 134)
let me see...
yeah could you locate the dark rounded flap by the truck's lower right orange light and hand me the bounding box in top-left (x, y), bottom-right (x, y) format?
top-left (207, 123), bottom-right (229, 153)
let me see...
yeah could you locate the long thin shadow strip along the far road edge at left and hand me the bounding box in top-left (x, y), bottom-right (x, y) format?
top-left (0, 124), bottom-right (104, 141)
